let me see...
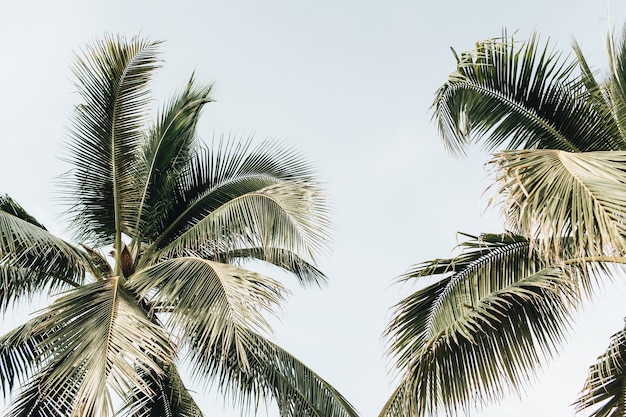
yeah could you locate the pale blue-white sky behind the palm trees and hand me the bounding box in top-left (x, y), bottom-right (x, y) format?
top-left (0, 0), bottom-right (626, 417)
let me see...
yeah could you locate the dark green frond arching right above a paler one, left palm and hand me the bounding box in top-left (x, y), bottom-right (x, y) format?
top-left (141, 141), bottom-right (328, 256)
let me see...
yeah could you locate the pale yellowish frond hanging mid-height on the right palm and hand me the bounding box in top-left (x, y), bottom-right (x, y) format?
top-left (492, 150), bottom-right (626, 261)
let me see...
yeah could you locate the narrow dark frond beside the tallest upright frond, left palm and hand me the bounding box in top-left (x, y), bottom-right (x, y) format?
top-left (132, 77), bottom-right (213, 242)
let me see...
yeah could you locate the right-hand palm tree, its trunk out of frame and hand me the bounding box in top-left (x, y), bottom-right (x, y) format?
top-left (380, 27), bottom-right (626, 417)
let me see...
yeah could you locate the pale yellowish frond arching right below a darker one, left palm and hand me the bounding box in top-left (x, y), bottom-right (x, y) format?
top-left (154, 181), bottom-right (328, 266)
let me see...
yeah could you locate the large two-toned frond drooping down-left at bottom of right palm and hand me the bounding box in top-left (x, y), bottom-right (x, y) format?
top-left (381, 235), bottom-right (588, 417)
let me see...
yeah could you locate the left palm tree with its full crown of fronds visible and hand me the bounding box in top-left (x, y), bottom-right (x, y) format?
top-left (0, 36), bottom-right (357, 417)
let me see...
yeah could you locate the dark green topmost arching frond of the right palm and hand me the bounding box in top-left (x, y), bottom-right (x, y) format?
top-left (433, 33), bottom-right (624, 154)
